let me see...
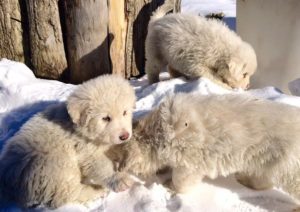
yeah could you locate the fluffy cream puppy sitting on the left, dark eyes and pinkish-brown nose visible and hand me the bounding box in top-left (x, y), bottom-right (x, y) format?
top-left (0, 75), bottom-right (135, 208)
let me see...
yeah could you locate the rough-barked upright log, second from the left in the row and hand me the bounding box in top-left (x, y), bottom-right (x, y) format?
top-left (26, 0), bottom-right (67, 79)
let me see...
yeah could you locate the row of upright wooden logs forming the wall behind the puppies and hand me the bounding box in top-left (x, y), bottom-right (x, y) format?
top-left (0, 0), bottom-right (180, 83)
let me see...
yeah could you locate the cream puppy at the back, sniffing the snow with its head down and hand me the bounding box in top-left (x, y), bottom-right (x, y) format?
top-left (145, 10), bottom-right (257, 89)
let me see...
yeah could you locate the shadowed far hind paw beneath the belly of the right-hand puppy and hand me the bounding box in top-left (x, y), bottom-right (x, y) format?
top-left (235, 173), bottom-right (273, 190)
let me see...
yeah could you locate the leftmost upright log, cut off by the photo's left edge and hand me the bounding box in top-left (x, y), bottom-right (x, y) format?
top-left (0, 0), bottom-right (24, 62)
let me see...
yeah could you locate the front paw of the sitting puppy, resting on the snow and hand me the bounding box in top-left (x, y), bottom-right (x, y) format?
top-left (111, 173), bottom-right (135, 192)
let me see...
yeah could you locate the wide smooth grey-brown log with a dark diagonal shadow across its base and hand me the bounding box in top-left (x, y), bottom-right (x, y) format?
top-left (65, 0), bottom-right (113, 83)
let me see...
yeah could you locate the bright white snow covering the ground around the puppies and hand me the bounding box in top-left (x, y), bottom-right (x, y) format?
top-left (0, 59), bottom-right (300, 212)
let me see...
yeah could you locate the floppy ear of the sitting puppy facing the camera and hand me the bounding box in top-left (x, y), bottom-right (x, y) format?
top-left (67, 94), bottom-right (88, 125)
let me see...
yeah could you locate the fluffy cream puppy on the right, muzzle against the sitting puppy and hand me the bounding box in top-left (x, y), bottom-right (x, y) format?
top-left (119, 94), bottom-right (300, 200)
